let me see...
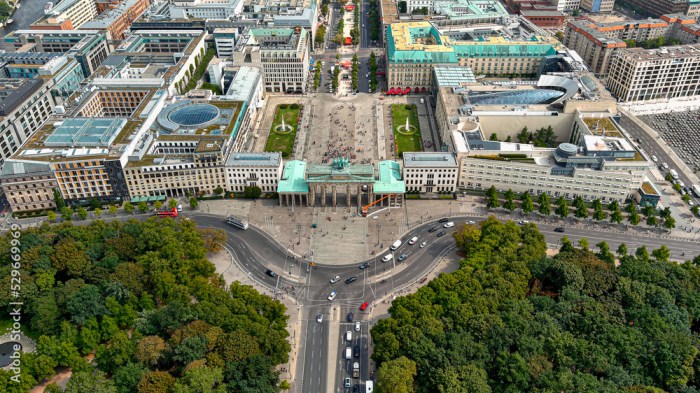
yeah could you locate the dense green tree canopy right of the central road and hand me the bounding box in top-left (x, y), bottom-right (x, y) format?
top-left (372, 219), bottom-right (700, 393)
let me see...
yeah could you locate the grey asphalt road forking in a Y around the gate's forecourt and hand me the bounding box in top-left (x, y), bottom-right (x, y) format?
top-left (189, 214), bottom-right (700, 393)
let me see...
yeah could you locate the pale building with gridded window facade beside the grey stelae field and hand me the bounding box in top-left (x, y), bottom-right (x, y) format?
top-left (607, 44), bottom-right (700, 101)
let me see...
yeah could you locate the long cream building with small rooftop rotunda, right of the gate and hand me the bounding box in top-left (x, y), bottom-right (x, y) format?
top-left (453, 114), bottom-right (651, 202)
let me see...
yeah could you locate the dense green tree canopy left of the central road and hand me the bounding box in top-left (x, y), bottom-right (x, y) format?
top-left (0, 219), bottom-right (290, 393)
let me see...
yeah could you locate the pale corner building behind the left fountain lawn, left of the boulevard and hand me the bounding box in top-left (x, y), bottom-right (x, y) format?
top-left (233, 28), bottom-right (309, 93)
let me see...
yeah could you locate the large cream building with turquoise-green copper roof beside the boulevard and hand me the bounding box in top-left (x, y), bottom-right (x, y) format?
top-left (386, 22), bottom-right (561, 91)
